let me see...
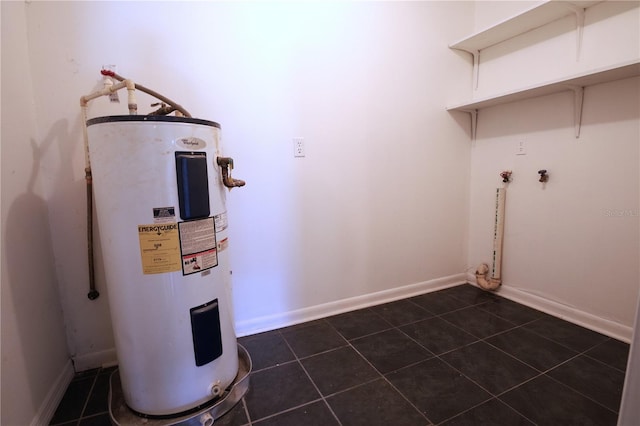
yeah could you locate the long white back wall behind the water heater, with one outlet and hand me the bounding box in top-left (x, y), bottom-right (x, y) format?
top-left (22, 2), bottom-right (473, 367)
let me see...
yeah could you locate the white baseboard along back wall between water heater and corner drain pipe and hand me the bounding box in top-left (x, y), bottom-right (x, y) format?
top-left (236, 273), bottom-right (467, 337)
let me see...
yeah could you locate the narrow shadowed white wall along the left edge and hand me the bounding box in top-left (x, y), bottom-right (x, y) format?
top-left (0, 2), bottom-right (73, 426)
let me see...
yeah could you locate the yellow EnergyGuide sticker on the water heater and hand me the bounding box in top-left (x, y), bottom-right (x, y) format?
top-left (138, 223), bottom-right (181, 275)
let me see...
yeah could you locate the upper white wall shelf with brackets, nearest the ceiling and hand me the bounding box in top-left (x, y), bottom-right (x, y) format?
top-left (449, 0), bottom-right (601, 89)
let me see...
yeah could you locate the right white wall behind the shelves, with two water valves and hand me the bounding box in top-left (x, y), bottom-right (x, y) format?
top-left (469, 2), bottom-right (640, 340)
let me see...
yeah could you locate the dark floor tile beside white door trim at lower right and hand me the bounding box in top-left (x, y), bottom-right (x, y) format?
top-left (547, 355), bottom-right (624, 413)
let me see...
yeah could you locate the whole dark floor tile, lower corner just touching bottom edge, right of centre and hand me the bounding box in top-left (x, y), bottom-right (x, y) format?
top-left (386, 358), bottom-right (491, 423)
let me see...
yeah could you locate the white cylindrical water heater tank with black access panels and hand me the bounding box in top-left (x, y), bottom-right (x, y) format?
top-left (87, 115), bottom-right (238, 416)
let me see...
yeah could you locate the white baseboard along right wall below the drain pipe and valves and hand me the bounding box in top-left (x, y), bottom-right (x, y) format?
top-left (467, 274), bottom-right (633, 343)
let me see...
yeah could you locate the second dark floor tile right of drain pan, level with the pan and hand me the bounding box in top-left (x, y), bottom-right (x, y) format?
top-left (301, 347), bottom-right (380, 396)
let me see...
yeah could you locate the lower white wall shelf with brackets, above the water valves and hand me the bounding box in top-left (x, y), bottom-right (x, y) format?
top-left (447, 59), bottom-right (640, 139)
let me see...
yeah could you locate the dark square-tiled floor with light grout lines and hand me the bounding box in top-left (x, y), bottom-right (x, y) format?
top-left (51, 285), bottom-right (629, 426)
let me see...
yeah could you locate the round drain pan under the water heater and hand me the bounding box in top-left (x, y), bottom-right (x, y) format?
top-left (109, 344), bottom-right (251, 426)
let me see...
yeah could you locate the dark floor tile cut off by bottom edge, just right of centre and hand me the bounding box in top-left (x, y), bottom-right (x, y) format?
top-left (328, 378), bottom-right (429, 426)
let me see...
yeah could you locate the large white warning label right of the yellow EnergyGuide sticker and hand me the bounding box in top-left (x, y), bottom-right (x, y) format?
top-left (178, 217), bottom-right (218, 275)
